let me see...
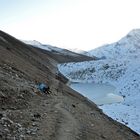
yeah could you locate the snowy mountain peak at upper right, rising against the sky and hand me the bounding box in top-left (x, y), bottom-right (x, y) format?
top-left (88, 29), bottom-right (140, 59)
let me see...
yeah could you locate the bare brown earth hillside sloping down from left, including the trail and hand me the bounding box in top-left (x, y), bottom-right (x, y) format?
top-left (0, 31), bottom-right (140, 140)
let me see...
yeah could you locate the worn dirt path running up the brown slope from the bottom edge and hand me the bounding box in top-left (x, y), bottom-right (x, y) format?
top-left (55, 103), bottom-right (79, 140)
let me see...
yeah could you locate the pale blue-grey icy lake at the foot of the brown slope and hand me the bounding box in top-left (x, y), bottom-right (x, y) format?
top-left (70, 83), bottom-right (124, 105)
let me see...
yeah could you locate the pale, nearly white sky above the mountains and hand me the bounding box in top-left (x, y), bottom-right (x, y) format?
top-left (0, 0), bottom-right (140, 50)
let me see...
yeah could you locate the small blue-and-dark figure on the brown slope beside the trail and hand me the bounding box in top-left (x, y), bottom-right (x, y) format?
top-left (38, 83), bottom-right (51, 94)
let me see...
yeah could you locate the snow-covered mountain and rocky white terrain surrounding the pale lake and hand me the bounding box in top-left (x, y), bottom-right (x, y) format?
top-left (59, 29), bottom-right (140, 133)
